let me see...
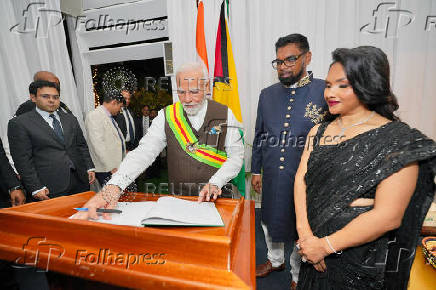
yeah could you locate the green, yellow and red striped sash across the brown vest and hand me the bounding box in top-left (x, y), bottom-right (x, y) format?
top-left (165, 102), bottom-right (227, 168)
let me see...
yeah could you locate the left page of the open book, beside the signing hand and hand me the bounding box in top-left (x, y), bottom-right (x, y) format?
top-left (70, 201), bottom-right (156, 227)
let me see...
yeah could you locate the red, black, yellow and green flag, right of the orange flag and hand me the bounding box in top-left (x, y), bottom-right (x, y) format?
top-left (213, 0), bottom-right (245, 196)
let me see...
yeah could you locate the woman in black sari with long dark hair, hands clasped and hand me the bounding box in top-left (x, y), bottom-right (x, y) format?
top-left (294, 46), bottom-right (436, 290)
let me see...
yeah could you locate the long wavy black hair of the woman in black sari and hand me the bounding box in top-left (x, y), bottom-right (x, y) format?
top-left (325, 46), bottom-right (399, 121)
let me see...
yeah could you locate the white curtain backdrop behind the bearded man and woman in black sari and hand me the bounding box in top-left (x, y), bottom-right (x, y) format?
top-left (168, 0), bottom-right (436, 169)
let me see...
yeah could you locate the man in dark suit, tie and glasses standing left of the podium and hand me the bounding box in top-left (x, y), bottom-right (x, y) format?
top-left (8, 81), bottom-right (95, 200)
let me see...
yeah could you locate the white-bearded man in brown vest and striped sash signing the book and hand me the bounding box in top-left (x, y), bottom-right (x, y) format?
top-left (75, 63), bottom-right (244, 219)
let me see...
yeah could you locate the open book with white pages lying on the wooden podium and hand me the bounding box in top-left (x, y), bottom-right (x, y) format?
top-left (79, 196), bottom-right (224, 227)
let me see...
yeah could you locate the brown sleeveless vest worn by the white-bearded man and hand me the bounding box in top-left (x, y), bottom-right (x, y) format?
top-left (164, 100), bottom-right (228, 195)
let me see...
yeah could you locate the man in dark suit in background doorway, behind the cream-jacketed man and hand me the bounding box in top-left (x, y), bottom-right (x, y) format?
top-left (115, 90), bottom-right (142, 151)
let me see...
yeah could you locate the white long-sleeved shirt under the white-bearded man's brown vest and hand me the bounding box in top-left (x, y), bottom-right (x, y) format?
top-left (108, 101), bottom-right (244, 190)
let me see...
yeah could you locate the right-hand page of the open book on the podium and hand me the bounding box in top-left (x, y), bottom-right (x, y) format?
top-left (142, 196), bottom-right (224, 227)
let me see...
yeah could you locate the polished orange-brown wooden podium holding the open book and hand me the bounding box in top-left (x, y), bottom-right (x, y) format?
top-left (0, 192), bottom-right (256, 289)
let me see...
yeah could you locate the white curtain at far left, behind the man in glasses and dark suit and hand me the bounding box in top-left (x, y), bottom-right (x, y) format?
top-left (0, 0), bottom-right (83, 143)
